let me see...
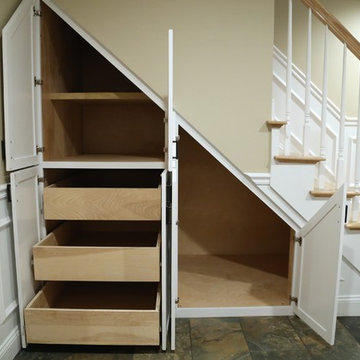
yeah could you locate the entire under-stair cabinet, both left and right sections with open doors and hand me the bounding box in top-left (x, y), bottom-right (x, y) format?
top-left (3, 0), bottom-right (346, 350)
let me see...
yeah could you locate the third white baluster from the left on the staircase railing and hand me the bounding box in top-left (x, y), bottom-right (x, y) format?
top-left (318, 25), bottom-right (329, 189)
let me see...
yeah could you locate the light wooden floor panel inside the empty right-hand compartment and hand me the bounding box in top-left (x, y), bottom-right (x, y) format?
top-left (179, 255), bottom-right (289, 308)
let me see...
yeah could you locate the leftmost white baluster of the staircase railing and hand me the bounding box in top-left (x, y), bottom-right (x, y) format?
top-left (283, 0), bottom-right (293, 155)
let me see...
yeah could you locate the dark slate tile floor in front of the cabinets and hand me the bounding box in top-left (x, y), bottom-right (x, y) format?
top-left (15, 317), bottom-right (360, 360)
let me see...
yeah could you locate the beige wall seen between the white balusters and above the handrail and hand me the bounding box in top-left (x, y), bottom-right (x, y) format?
top-left (274, 0), bottom-right (360, 116)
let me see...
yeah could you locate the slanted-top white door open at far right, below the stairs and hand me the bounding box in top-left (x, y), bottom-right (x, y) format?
top-left (293, 186), bottom-right (346, 345)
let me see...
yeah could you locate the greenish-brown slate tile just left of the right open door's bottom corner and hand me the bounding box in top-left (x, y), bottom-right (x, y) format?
top-left (240, 317), bottom-right (306, 353)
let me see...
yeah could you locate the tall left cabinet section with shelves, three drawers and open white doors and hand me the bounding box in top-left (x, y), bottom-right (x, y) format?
top-left (3, 0), bottom-right (170, 349)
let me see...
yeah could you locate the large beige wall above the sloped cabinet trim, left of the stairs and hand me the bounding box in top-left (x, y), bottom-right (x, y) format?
top-left (54, 0), bottom-right (274, 172)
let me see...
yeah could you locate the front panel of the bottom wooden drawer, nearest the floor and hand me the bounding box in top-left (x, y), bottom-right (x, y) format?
top-left (25, 308), bottom-right (160, 345)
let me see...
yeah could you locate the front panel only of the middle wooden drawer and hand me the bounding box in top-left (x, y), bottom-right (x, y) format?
top-left (33, 244), bottom-right (160, 281)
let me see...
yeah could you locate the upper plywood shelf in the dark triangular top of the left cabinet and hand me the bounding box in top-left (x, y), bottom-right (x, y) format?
top-left (49, 92), bottom-right (151, 103)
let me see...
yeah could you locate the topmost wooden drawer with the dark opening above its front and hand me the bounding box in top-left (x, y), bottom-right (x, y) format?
top-left (44, 170), bottom-right (161, 221)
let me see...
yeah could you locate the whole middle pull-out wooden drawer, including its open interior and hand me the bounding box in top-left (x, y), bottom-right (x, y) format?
top-left (33, 221), bottom-right (160, 282)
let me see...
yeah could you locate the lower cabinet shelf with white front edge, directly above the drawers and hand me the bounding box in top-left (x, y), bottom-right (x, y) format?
top-left (43, 154), bottom-right (165, 169)
